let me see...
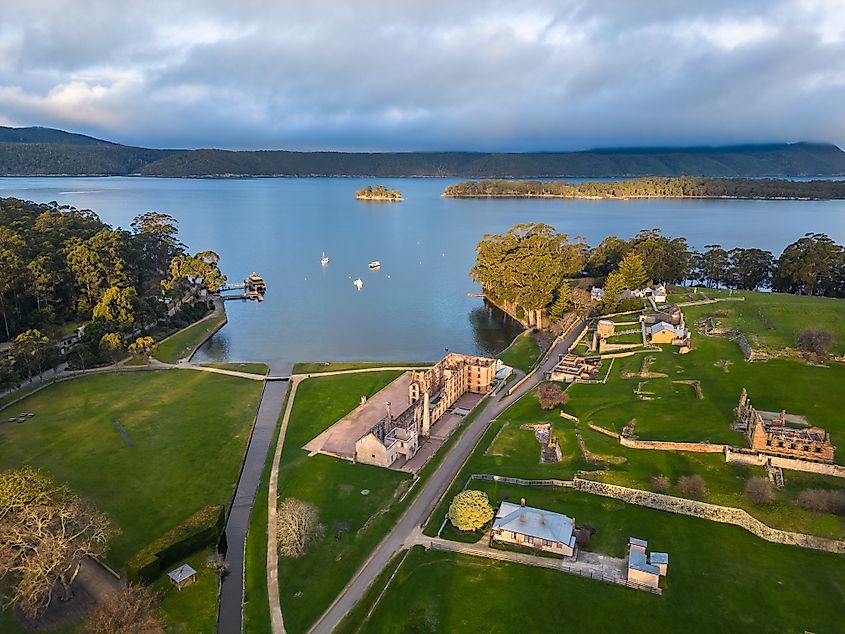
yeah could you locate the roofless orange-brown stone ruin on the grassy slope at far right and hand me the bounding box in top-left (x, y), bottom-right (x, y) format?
top-left (736, 388), bottom-right (836, 463)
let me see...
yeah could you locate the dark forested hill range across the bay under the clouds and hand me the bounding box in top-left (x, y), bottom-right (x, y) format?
top-left (0, 127), bottom-right (845, 178)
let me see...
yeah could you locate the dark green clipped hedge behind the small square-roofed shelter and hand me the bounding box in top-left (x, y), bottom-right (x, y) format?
top-left (126, 504), bottom-right (226, 583)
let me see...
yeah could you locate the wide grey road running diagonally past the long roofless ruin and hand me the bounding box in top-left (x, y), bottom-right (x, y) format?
top-left (311, 322), bottom-right (586, 634)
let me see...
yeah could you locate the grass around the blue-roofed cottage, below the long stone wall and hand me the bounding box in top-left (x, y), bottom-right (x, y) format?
top-left (358, 486), bottom-right (845, 634)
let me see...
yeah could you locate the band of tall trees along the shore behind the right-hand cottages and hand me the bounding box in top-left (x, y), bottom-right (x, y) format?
top-left (470, 224), bottom-right (845, 327)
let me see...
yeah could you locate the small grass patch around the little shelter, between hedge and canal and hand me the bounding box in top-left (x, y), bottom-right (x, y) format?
top-left (153, 549), bottom-right (220, 634)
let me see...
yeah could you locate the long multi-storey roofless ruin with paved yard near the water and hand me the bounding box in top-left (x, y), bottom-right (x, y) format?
top-left (305, 353), bottom-right (496, 468)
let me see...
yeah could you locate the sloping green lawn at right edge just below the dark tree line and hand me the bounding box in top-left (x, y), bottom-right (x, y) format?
top-left (684, 290), bottom-right (845, 356)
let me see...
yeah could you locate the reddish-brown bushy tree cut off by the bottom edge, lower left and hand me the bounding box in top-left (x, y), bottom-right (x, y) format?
top-left (85, 585), bottom-right (165, 634)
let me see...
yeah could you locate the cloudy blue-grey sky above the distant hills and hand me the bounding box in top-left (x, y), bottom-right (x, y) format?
top-left (0, 0), bottom-right (845, 151)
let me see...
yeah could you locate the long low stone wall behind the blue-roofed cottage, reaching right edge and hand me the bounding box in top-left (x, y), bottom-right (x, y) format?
top-left (574, 478), bottom-right (845, 555)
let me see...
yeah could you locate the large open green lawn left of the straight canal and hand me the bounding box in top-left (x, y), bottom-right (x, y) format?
top-left (0, 370), bottom-right (261, 568)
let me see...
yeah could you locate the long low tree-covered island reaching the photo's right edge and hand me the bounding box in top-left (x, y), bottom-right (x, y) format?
top-left (443, 176), bottom-right (845, 200)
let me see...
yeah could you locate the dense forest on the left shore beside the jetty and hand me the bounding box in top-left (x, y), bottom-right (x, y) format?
top-left (0, 198), bottom-right (225, 390)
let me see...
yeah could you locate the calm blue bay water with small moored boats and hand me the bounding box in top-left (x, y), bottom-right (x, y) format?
top-left (0, 177), bottom-right (845, 371)
